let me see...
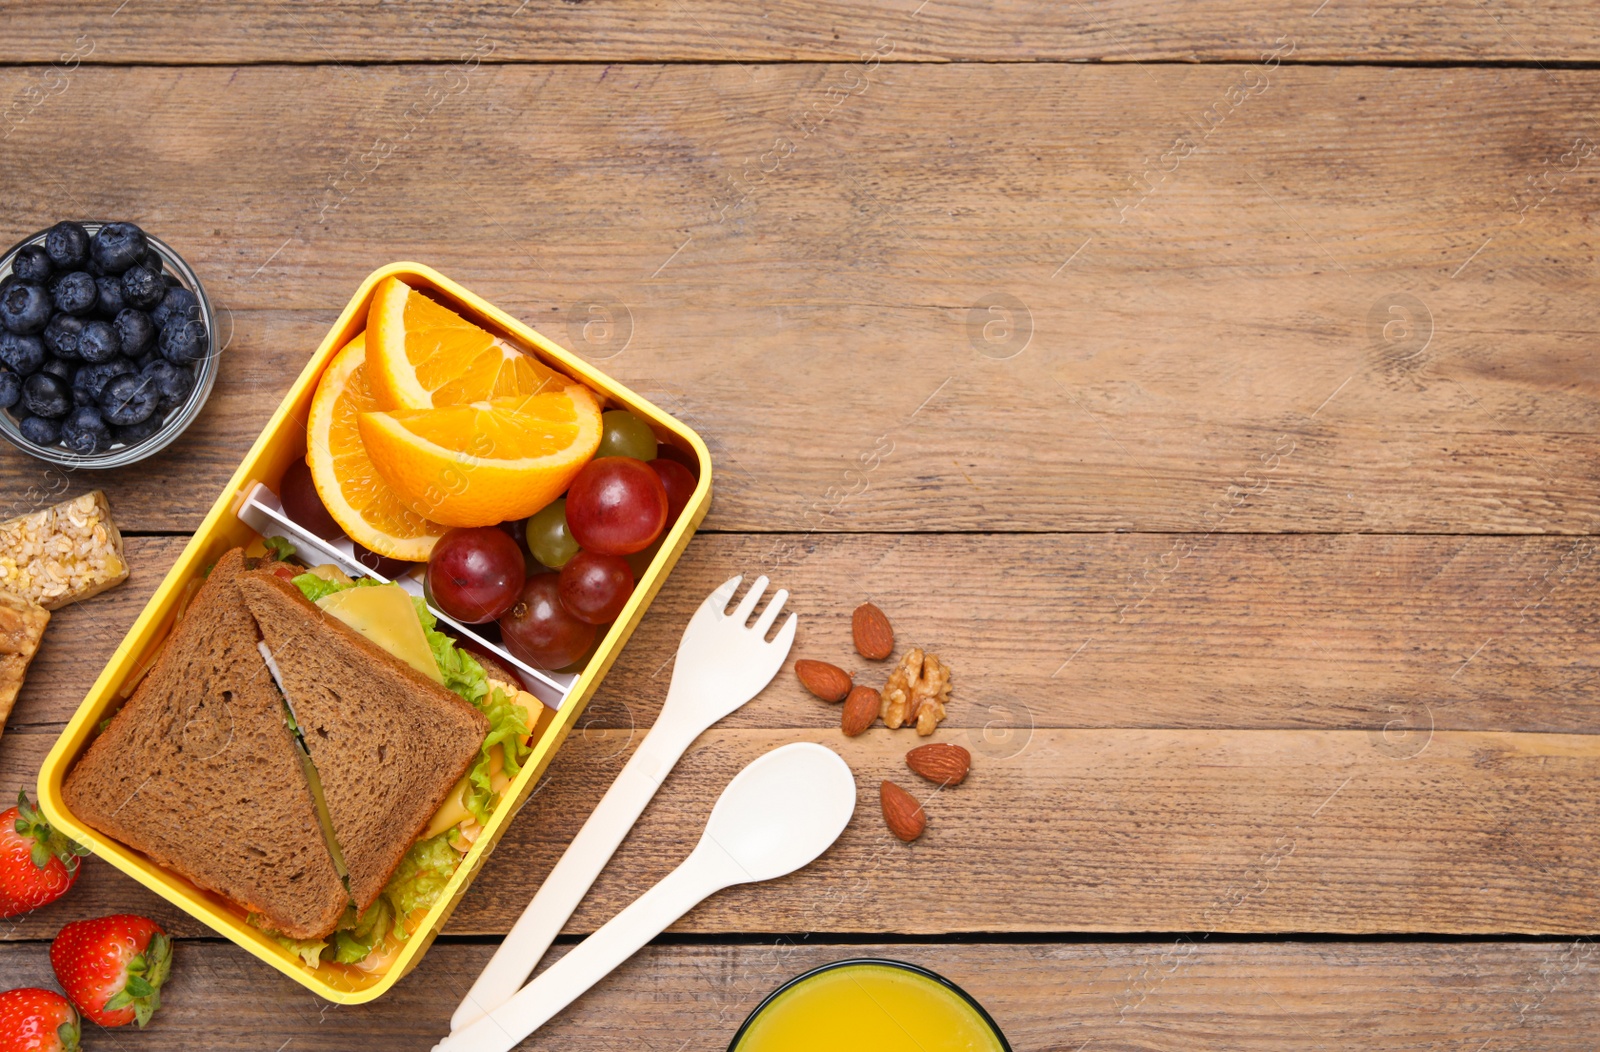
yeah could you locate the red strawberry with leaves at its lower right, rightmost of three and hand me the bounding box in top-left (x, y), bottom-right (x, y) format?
top-left (50, 913), bottom-right (173, 1026)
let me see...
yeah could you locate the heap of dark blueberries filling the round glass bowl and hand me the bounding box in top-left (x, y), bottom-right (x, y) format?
top-left (0, 221), bottom-right (211, 462)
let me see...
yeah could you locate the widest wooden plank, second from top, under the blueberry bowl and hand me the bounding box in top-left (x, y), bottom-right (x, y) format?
top-left (0, 64), bottom-right (1600, 534)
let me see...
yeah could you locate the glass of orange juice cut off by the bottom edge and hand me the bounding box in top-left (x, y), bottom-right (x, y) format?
top-left (728, 958), bottom-right (1011, 1052)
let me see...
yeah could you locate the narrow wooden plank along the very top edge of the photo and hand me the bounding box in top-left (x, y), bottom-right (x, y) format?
top-left (0, 0), bottom-right (1600, 64)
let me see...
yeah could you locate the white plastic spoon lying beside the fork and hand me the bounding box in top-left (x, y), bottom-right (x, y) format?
top-left (434, 742), bottom-right (856, 1052)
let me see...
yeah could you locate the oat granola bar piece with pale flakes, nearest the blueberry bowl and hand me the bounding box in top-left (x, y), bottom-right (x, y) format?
top-left (0, 489), bottom-right (128, 611)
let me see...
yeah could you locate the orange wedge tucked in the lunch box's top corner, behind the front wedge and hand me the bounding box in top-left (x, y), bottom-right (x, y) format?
top-left (366, 278), bottom-right (573, 409)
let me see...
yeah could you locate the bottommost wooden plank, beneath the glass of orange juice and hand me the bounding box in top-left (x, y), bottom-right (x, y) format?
top-left (0, 938), bottom-right (1600, 1052)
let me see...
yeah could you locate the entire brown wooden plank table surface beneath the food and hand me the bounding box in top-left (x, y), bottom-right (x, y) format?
top-left (0, 0), bottom-right (1600, 1052)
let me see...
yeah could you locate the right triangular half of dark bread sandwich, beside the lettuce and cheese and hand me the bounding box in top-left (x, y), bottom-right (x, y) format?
top-left (240, 571), bottom-right (490, 911)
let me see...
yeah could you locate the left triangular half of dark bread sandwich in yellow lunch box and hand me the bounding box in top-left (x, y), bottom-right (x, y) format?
top-left (62, 548), bottom-right (349, 938)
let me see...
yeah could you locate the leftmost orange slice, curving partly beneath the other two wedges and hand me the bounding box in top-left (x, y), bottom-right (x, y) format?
top-left (306, 334), bottom-right (448, 563)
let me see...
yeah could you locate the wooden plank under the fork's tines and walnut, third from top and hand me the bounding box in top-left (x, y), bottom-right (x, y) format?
top-left (0, 534), bottom-right (1600, 738)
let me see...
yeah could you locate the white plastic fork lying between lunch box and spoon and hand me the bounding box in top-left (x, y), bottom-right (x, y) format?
top-left (450, 574), bottom-right (798, 1031)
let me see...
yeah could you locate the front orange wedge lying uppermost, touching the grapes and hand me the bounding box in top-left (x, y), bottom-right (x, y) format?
top-left (360, 384), bottom-right (600, 526)
